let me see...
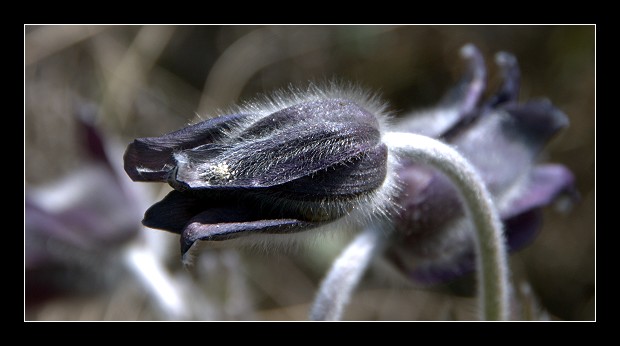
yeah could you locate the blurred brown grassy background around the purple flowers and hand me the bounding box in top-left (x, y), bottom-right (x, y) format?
top-left (25, 26), bottom-right (595, 320)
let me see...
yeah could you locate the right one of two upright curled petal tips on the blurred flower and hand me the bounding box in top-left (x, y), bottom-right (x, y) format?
top-left (485, 52), bottom-right (521, 108)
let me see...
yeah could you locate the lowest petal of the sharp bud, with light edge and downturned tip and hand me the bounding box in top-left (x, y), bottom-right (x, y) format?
top-left (181, 208), bottom-right (314, 255)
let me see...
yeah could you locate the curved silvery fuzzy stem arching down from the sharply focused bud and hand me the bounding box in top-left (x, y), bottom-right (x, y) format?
top-left (383, 132), bottom-right (509, 320)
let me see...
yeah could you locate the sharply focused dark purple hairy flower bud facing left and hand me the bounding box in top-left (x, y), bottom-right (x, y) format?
top-left (125, 90), bottom-right (392, 254)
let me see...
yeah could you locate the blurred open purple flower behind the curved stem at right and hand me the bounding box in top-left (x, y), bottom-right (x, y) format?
top-left (386, 46), bottom-right (576, 283)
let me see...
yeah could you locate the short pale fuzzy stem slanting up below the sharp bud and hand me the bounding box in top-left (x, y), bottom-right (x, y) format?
top-left (310, 227), bottom-right (387, 321)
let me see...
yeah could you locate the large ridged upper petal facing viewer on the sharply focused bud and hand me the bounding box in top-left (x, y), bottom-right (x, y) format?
top-left (174, 100), bottom-right (385, 189)
